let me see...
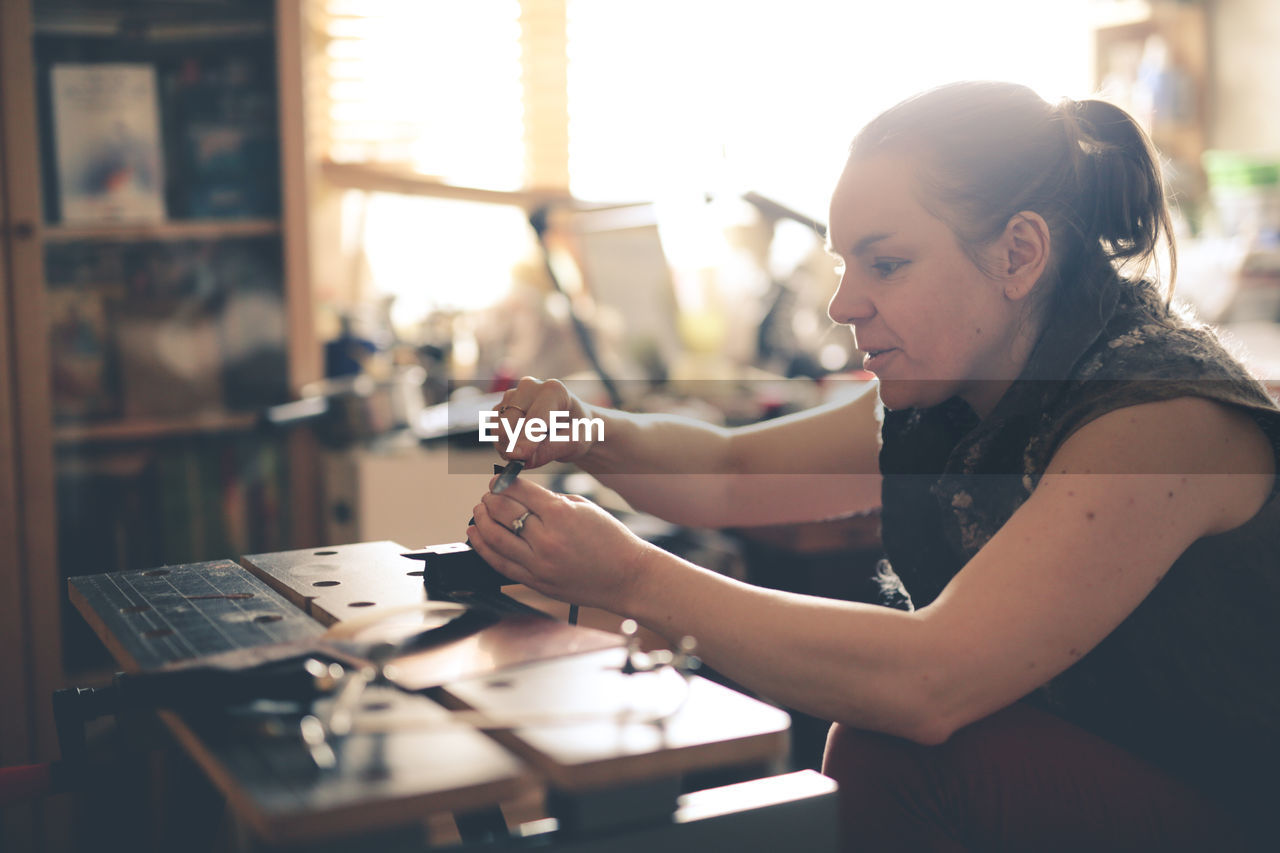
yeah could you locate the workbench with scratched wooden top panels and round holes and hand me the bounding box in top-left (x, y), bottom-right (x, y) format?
top-left (68, 542), bottom-right (837, 852)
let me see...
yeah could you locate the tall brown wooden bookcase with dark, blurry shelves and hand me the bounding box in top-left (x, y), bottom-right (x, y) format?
top-left (0, 0), bottom-right (320, 849)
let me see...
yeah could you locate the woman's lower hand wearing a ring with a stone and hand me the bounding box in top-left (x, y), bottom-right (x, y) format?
top-left (467, 478), bottom-right (654, 615)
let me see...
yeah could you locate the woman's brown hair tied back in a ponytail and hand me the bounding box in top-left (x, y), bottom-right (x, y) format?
top-left (850, 81), bottom-right (1178, 304)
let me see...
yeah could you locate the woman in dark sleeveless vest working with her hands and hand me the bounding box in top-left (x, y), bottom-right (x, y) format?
top-left (467, 83), bottom-right (1280, 850)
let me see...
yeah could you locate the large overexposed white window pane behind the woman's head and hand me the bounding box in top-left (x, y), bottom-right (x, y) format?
top-left (568, 0), bottom-right (1091, 219)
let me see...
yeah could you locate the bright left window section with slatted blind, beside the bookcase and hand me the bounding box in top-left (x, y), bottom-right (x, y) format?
top-left (308, 0), bottom-right (525, 188)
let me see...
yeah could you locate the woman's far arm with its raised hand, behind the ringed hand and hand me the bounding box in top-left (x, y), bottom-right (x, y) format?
top-left (499, 379), bottom-right (879, 528)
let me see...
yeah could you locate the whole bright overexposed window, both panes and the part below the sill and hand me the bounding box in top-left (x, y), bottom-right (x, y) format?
top-left (311, 0), bottom-right (1092, 330)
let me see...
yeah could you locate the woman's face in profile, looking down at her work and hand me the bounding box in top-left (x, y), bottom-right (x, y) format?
top-left (828, 155), bottom-right (1027, 415)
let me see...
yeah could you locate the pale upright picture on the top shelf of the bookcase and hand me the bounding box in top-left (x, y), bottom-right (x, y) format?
top-left (51, 63), bottom-right (165, 225)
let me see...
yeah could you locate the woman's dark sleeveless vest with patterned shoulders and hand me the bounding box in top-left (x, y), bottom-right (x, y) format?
top-left (881, 280), bottom-right (1280, 815)
